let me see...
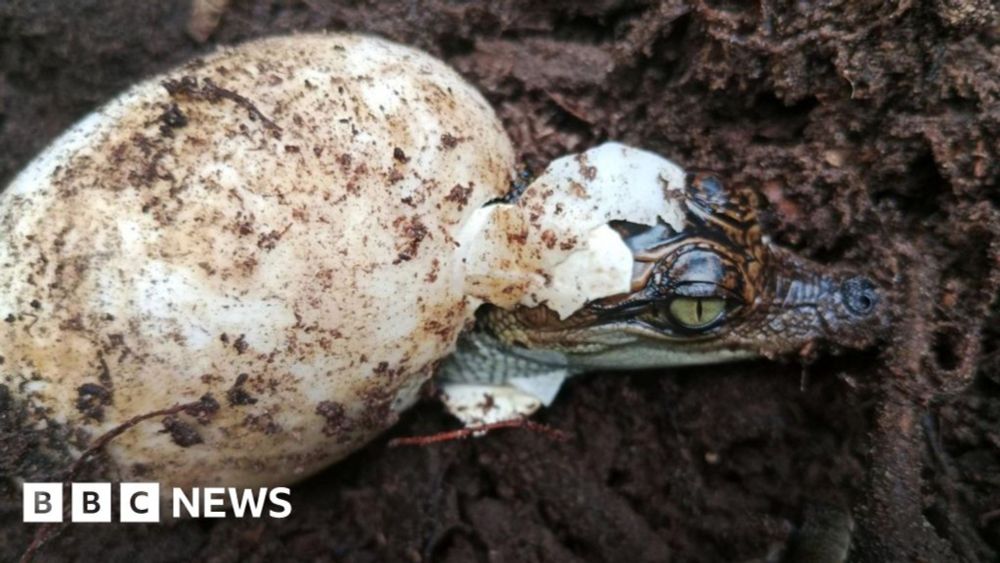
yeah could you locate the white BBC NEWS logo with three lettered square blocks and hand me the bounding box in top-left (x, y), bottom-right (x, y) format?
top-left (22, 483), bottom-right (292, 523)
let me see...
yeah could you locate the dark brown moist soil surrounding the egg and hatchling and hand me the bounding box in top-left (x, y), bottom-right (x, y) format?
top-left (0, 0), bottom-right (1000, 562)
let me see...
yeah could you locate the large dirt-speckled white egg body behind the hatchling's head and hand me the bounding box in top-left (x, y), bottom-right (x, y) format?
top-left (0, 35), bottom-right (514, 487)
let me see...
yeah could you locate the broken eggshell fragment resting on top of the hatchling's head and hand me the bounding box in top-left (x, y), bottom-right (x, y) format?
top-left (463, 143), bottom-right (685, 318)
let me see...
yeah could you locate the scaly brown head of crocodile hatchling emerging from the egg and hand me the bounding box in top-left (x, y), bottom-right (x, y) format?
top-left (441, 174), bottom-right (885, 383)
